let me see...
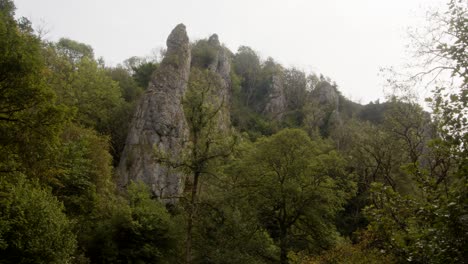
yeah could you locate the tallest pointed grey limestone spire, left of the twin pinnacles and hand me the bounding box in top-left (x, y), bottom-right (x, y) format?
top-left (118, 24), bottom-right (191, 203)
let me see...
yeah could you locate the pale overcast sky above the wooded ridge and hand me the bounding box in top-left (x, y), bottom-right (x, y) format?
top-left (14, 0), bottom-right (446, 103)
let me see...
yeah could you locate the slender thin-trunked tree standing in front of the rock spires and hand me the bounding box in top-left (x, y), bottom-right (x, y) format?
top-left (165, 68), bottom-right (236, 263)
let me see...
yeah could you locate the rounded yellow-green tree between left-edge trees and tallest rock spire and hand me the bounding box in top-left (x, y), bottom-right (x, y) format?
top-left (49, 124), bottom-right (113, 217)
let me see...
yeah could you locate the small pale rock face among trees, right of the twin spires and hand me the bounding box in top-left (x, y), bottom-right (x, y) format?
top-left (263, 75), bottom-right (287, 120)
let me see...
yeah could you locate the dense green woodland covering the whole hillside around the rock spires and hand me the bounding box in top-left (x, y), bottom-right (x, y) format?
top-left (0, 0), bottom-right (468, 264)
